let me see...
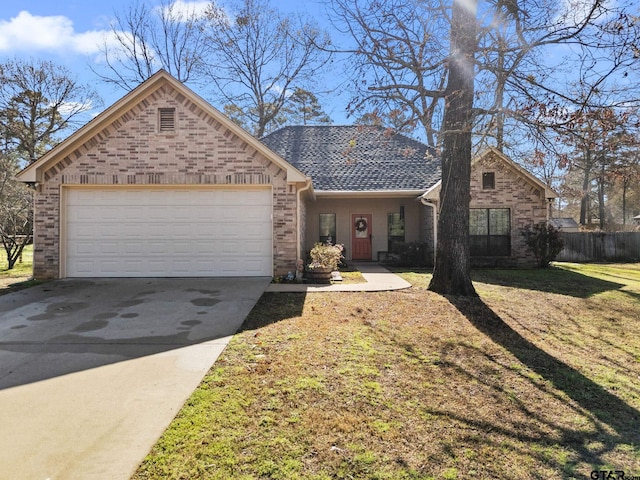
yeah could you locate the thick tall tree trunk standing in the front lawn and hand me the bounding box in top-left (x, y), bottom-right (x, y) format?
top-left (429, 0), bottom-right (478, 296)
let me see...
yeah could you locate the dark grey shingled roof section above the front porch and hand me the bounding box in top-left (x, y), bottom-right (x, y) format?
top-left (262, 125), bottom-right (441, 192)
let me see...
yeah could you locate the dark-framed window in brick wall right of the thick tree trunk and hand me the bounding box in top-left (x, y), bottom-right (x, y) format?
top-left (469, 208), bottom-right (511, 257)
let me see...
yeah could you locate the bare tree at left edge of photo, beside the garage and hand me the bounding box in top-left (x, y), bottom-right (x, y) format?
top-left (0, 60), bottom-right (100, 269)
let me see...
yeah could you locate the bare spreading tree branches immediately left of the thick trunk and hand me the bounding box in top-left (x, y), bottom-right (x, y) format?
top-left (332, 0), bottom-right (450, 147)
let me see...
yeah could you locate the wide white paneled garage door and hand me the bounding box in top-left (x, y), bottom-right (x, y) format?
top-left (62, 187), bottom-right (273, 277)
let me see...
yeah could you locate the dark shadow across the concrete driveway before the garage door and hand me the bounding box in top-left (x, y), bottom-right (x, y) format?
top-left (0, 277), bottom-right (270, 389)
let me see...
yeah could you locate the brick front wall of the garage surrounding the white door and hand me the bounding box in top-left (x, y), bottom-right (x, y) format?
top-left (34, 85), bottom-right (297, 278)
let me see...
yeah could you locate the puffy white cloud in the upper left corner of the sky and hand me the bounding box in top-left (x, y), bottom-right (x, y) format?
top-left (0, 11), bottom-right (110, 54)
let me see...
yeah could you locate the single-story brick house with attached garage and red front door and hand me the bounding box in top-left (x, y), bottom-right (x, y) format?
top-left (18, 71), bottom-right (555, 278)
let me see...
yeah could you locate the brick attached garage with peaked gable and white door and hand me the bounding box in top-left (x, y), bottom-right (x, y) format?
top-left (18, 71), bottom-right (313, 279)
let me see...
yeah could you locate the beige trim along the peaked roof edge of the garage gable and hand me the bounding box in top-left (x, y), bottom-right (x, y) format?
top-left (17, 70), bottom-right (307, 183)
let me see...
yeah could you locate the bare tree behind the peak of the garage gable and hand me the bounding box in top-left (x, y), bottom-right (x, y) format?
top-left (91, 0), bottom-right (205, 90)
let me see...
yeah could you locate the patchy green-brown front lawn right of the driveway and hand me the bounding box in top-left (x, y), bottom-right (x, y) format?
top-left (134, 264), bottom-right (640, 479)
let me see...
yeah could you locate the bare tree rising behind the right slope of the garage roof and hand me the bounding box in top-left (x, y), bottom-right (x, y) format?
top-left (204, 0), bottom-right (330, 138)
